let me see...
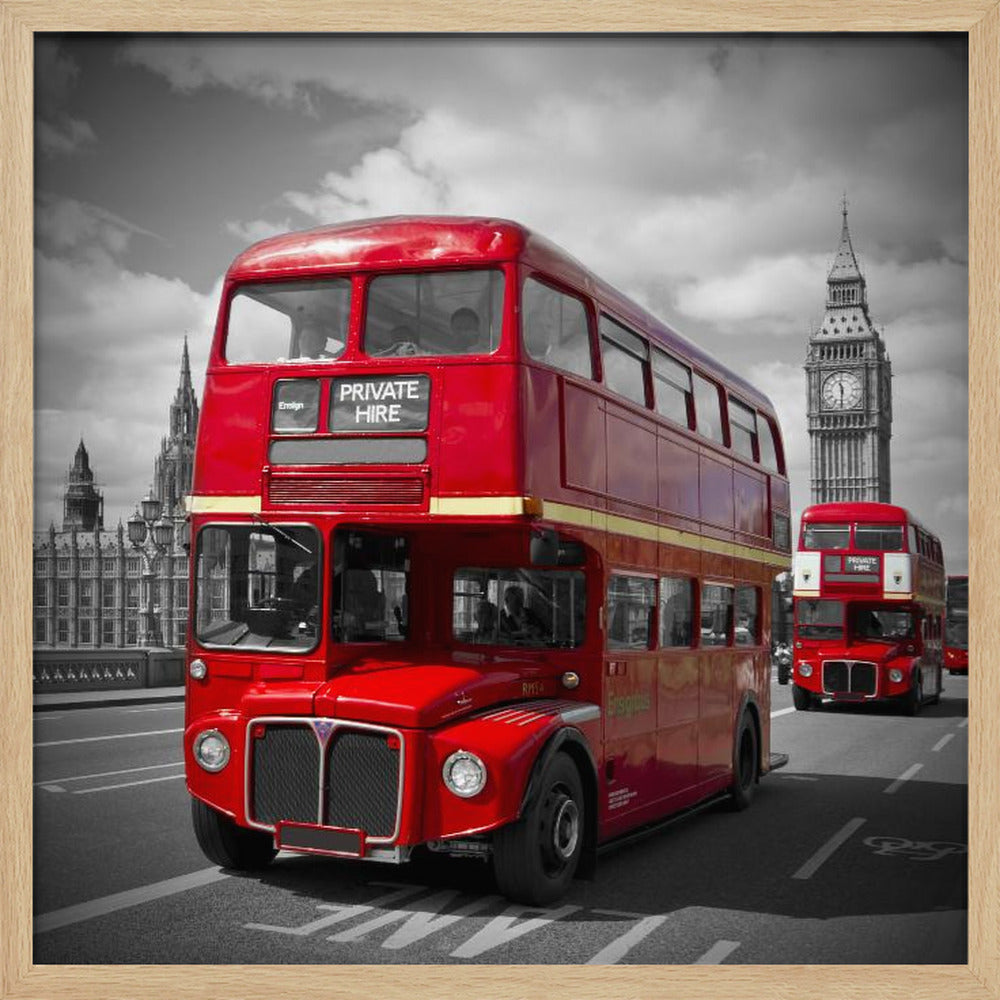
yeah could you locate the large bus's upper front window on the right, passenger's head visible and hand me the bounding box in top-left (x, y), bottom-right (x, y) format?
top-left (362, 270), bottom-right (504, 358)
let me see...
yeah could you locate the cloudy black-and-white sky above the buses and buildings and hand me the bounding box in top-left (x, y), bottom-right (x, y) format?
top-left (35, 35), bottom-right (968, 573)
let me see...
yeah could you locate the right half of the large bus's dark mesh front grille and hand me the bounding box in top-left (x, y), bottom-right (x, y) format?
top-left (323, 728), bottom-right (400, 837)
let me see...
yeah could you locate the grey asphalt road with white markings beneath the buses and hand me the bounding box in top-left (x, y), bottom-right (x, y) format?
top-left (34, 677), bottom-right (968, 964)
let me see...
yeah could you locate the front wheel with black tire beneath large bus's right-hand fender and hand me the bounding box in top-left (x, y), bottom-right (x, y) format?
top-left (493, 753), bottom-right (586, 906)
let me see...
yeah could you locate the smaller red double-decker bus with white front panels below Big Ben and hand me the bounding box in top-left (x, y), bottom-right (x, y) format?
top-left (792, 503), bottom-right (945, 715)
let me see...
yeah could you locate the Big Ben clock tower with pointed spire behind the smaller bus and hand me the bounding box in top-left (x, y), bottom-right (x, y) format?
top-left (805, 198), bottom-right (892, 503)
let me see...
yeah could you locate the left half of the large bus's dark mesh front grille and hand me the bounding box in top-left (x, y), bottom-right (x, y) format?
top-left (251, 724), bottom-right (319, 826)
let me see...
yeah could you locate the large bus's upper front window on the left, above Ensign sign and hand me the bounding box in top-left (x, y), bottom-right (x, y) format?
top-left (225, 278), bottom-right (351, 364)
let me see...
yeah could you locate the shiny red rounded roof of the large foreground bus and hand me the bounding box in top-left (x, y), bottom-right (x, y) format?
top-left (227, 215), bottom-right (774, 416)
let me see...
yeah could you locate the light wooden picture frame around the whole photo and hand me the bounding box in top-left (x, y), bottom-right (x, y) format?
top-left (0, 0), bottom-right (1000, 1000)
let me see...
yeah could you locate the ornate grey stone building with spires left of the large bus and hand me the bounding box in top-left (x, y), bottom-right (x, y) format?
top-left (32, 339), bottom-right (198, 649)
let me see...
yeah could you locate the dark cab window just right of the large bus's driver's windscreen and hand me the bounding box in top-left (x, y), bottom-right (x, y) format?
top-left (331, 530), bottom-right (410, 642)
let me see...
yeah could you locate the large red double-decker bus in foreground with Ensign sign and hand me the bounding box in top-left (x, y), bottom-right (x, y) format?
top-left (184, 217), bottom-right (790, 903)
